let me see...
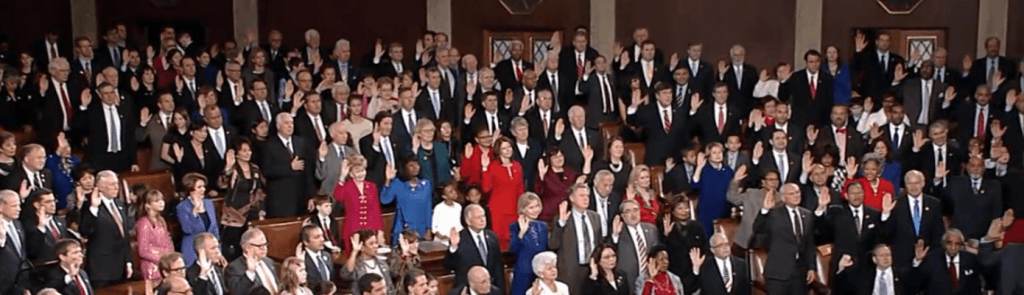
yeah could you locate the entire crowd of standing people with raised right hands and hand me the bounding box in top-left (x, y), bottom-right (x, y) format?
top-left (0, 20), bottom-right (1024, 295)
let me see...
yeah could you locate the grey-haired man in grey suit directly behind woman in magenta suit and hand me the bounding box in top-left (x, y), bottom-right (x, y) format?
top-left (316, 122), bottom-right (356, 196)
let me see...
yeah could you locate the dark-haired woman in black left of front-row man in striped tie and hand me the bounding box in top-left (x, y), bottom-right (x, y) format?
top-left (657, 192), bottom-right (710, 282)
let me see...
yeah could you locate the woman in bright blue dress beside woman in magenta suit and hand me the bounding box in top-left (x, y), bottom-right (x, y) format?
top-left (381, 158), bottom-right (433, 245)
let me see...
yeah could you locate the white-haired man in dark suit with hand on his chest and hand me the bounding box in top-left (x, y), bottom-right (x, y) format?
top-left (261, 113), bottom-right (315, 217)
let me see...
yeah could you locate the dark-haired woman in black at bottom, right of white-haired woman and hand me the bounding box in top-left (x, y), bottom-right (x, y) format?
top-left (583, 244), bottom-right (633, 295)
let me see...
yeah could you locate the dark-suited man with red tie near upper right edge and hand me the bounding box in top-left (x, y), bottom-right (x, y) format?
top-left (954, 85), bottom-right (1005, 143)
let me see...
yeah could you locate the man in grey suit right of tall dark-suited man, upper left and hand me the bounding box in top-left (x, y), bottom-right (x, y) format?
top-left (135, 92), bottom-right (175, 172)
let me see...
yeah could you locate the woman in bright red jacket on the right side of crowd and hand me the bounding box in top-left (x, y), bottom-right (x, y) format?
top-left (843, 153), bottom-right (896, 210)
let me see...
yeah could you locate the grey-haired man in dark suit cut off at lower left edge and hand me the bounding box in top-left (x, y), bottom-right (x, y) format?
top-left (0, 189), bottom-right (32, 294)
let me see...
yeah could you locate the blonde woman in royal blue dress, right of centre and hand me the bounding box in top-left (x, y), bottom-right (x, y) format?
top-left (690, 142), bottom-right (733, 234)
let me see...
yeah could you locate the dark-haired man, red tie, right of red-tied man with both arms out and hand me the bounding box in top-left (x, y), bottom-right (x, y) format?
top-left (689, 82), bottom-right (742, 142)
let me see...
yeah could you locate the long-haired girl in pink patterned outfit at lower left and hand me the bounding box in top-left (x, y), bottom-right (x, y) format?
top-left (135, 189), bottom-right (174, 281)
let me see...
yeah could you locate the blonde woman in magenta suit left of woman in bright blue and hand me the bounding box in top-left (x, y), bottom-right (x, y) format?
top-left (334, 155), bottom-right (384, 254)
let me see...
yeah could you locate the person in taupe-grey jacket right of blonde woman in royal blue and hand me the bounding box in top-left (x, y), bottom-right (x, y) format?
top-left (725, 166), bottom-right (779, 249)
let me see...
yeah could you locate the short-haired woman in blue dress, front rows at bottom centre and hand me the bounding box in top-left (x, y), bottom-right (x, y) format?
top-left (507, 192), bottom-right (548, 295)
